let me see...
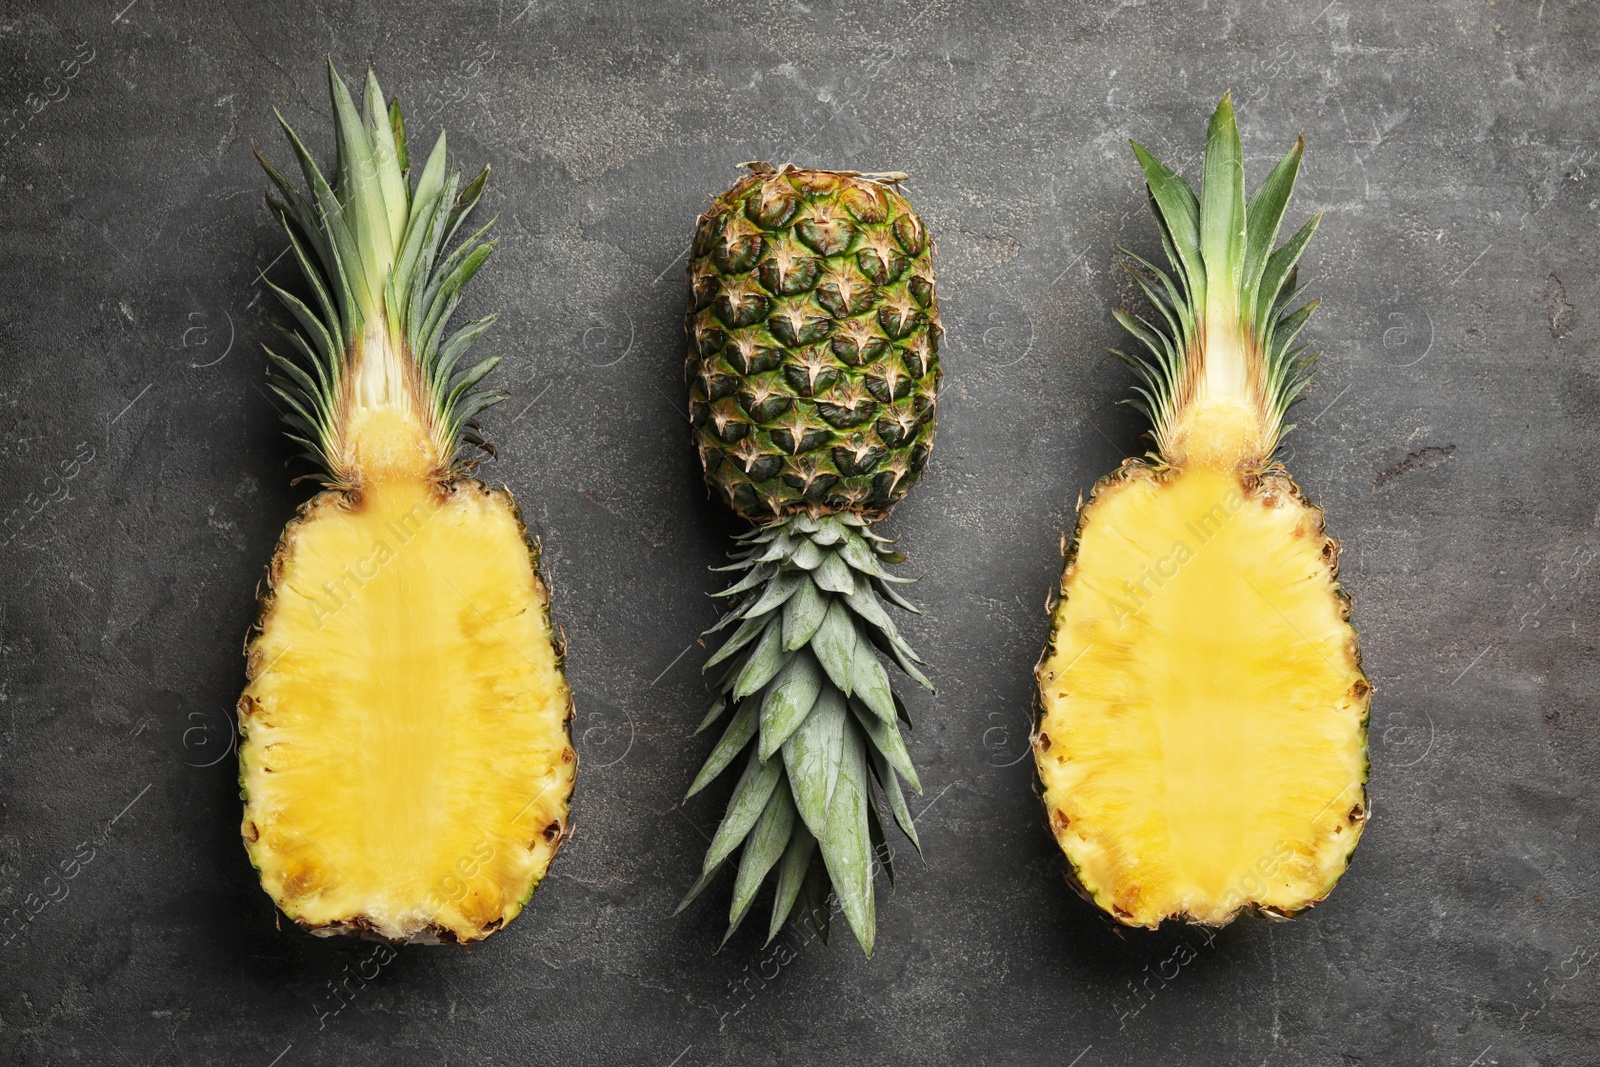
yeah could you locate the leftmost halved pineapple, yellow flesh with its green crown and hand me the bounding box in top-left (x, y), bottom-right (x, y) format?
top-left (238, 62), bottom-right (578, 942)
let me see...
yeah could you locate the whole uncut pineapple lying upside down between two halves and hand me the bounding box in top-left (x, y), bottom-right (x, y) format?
top-left (678, 163), bottom-right (941, 955)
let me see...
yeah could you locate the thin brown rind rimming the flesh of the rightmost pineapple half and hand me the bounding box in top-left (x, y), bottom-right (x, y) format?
top-left (1032, 458), bottom-right (1373, 929)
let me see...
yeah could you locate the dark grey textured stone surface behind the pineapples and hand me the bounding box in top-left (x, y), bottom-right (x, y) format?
top-left (0, 0), bottom-right (1600, 1067)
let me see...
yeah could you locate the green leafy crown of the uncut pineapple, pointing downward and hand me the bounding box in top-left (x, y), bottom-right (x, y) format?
top-left (678, 512), bottom-right (933, 957)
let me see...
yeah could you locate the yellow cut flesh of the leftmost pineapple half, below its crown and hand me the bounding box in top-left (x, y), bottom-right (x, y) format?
top-left (240, 479), bottom-right (576, 942)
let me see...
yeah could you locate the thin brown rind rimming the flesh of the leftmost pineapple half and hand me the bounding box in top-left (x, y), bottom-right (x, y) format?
top-left (238, 478), bottom-right (578, 944)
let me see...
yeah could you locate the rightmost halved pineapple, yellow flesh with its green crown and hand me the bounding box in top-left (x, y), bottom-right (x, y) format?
top-left (1034, 96), bottom-right (1371, 928)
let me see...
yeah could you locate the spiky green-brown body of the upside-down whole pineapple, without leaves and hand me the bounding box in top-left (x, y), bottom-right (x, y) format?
top-left (685, 163), bottom-right (942, 523)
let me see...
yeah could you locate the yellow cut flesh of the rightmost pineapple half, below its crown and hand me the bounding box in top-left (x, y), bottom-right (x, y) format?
top-left (1035, 462), bottom-right (1371, 926)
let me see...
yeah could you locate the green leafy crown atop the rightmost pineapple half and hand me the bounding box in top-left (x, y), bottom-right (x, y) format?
top-left (1115, 94), bottom-right (1322, 467)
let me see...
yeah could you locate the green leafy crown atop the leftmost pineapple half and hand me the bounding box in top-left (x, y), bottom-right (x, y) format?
top-left (256, 59), bottom-right (507, 486)
